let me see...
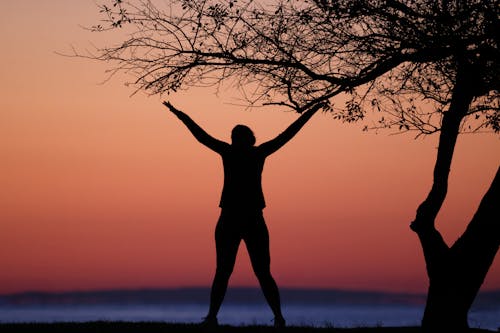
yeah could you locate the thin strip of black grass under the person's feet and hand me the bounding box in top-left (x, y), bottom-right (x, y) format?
top-left (0, 321), bottom-right (492, 333)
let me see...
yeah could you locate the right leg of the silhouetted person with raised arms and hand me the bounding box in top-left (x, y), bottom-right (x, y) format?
top-left (243, 212), bottom-right (285, 327)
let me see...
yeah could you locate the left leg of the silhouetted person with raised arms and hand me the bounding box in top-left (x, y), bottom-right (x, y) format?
top-left (205, 213), bottom-right (240, 321)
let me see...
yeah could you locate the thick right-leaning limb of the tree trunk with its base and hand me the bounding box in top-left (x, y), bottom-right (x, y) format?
top-left (422, 168), bottom-right (500, 332)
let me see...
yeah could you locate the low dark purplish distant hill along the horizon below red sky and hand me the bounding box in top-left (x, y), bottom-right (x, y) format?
top-left (0, 287), bottom-right (500, 309)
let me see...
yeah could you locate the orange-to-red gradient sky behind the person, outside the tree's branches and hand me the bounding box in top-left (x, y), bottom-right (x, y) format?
top-left (0, 0), bottom-right (500, 293)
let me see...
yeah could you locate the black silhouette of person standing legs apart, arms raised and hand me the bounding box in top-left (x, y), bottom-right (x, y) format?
top-left (163, 102), bottom-right (320, 327)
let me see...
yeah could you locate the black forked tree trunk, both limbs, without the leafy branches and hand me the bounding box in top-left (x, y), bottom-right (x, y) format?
top-left (411, 65), bottom-right (500, 332)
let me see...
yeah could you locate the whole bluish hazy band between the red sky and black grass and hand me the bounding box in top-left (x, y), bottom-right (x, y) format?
top-left (0, 287), bottom-right (500, 330)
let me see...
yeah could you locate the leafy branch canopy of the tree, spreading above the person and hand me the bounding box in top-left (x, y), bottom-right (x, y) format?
top-left (89, 0), bottom-right (500, 134)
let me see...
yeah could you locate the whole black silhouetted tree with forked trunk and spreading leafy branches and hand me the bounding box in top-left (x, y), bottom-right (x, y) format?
top-left (83, 0), bottom-right (500, 329)
